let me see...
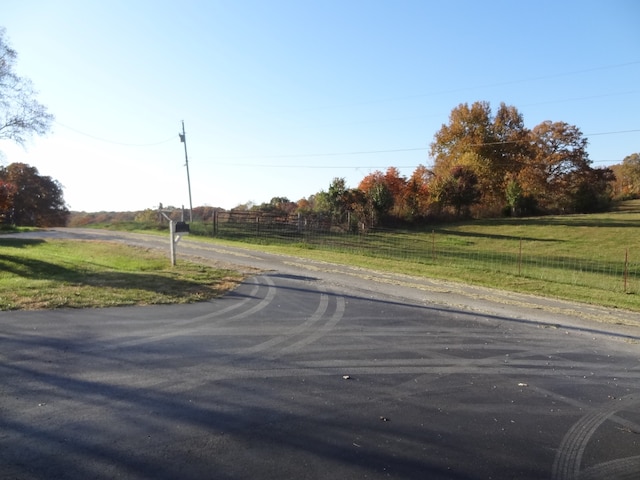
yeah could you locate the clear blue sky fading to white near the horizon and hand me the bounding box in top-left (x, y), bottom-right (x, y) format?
top-left (0, 0), bottom-right (640, 211)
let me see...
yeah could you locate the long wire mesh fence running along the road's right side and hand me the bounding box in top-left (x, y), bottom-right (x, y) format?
top-left (191, 212), bottom-right (640, 293)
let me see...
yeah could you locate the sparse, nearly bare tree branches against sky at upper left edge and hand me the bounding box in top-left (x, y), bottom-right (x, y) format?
top-left (0, 27), bottom-right (53, 145)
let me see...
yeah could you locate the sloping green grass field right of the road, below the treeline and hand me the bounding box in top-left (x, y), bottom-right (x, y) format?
top-left (186, 200), bottom-right (640, 311)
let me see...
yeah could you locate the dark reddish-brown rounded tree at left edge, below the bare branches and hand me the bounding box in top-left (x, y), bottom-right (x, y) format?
top-left (0, 163), bottom-right (69, 227)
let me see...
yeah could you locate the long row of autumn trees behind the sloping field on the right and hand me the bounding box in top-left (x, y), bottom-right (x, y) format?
top-left (238, 102), bottom-right (640, 226)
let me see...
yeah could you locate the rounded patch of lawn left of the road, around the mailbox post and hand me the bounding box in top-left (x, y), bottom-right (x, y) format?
top-left (0, 237), bottom-right (241, 310)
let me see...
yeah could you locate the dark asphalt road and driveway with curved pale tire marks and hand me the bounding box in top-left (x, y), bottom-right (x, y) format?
top-left (0, 230), bottom-right (640, 480)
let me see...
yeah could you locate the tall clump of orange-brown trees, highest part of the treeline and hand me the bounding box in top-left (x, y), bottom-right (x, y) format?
top-left (431, 102), bottom-right (614, 216)
